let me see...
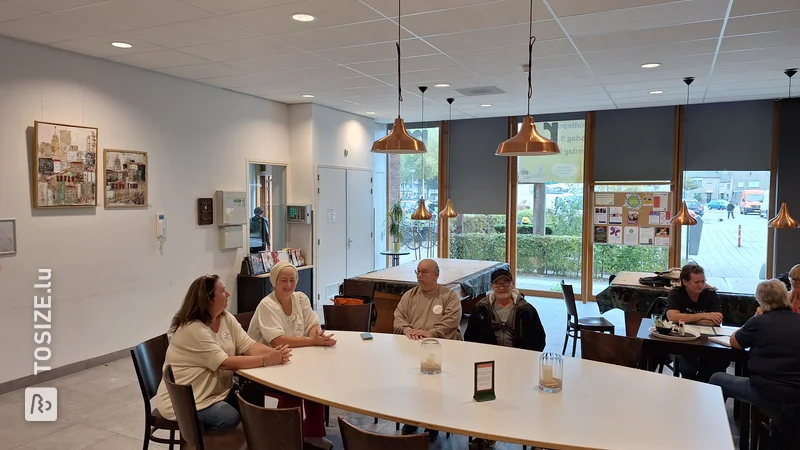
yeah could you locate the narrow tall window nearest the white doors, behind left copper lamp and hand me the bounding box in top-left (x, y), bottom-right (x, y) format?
top-left (389, 124), bottom-right (439, 264)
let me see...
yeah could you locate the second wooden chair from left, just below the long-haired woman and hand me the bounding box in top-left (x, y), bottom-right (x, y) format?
top-left (164, 365), bottom-right (247, 450)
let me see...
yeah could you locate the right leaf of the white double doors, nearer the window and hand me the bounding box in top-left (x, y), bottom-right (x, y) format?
top-left (347, 170), bottom-right (375, 278)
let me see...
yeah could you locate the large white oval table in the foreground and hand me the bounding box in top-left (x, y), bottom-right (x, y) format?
top-left (239, 331), bottom-right (734, 450)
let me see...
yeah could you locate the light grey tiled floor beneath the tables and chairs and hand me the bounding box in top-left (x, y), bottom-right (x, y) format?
top-left (0, 298), bottom-right (744, 450)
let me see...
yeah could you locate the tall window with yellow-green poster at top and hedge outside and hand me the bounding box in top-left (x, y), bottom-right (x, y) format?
top-left (515, 119), bottom-right (585, 293)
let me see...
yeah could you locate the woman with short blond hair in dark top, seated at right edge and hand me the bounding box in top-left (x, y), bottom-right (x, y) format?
top-left (709, 279), bottom-right (800, 414)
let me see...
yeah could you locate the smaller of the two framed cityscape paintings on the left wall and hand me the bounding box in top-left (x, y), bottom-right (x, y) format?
top-left (103, 148), bottom-right (149, 208)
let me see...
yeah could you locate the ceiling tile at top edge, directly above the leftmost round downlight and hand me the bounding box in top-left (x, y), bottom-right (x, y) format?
top-left (55, 0), bottom-right (211, 31)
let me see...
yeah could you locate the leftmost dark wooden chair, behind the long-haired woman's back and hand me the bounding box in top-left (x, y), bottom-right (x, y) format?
top-left (131, 334), bottom-right (181, 450)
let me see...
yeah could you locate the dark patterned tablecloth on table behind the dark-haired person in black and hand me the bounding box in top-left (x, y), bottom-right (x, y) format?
top-left (596, 285), bottom-right (758, 326)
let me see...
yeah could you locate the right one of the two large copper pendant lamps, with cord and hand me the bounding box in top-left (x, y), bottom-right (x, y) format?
top-left (495, 0), bottom-right (561, 156)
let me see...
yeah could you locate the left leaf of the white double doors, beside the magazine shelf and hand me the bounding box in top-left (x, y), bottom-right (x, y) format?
top-left (314, 167), bottom-right (347, 309)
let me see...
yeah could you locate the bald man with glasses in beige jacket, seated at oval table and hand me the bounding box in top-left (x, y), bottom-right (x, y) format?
top-left (394, 259), bottom-right (464, 341)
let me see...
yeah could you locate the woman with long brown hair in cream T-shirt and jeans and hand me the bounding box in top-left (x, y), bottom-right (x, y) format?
top-left (156, 275), bottom-right (291, 429)
